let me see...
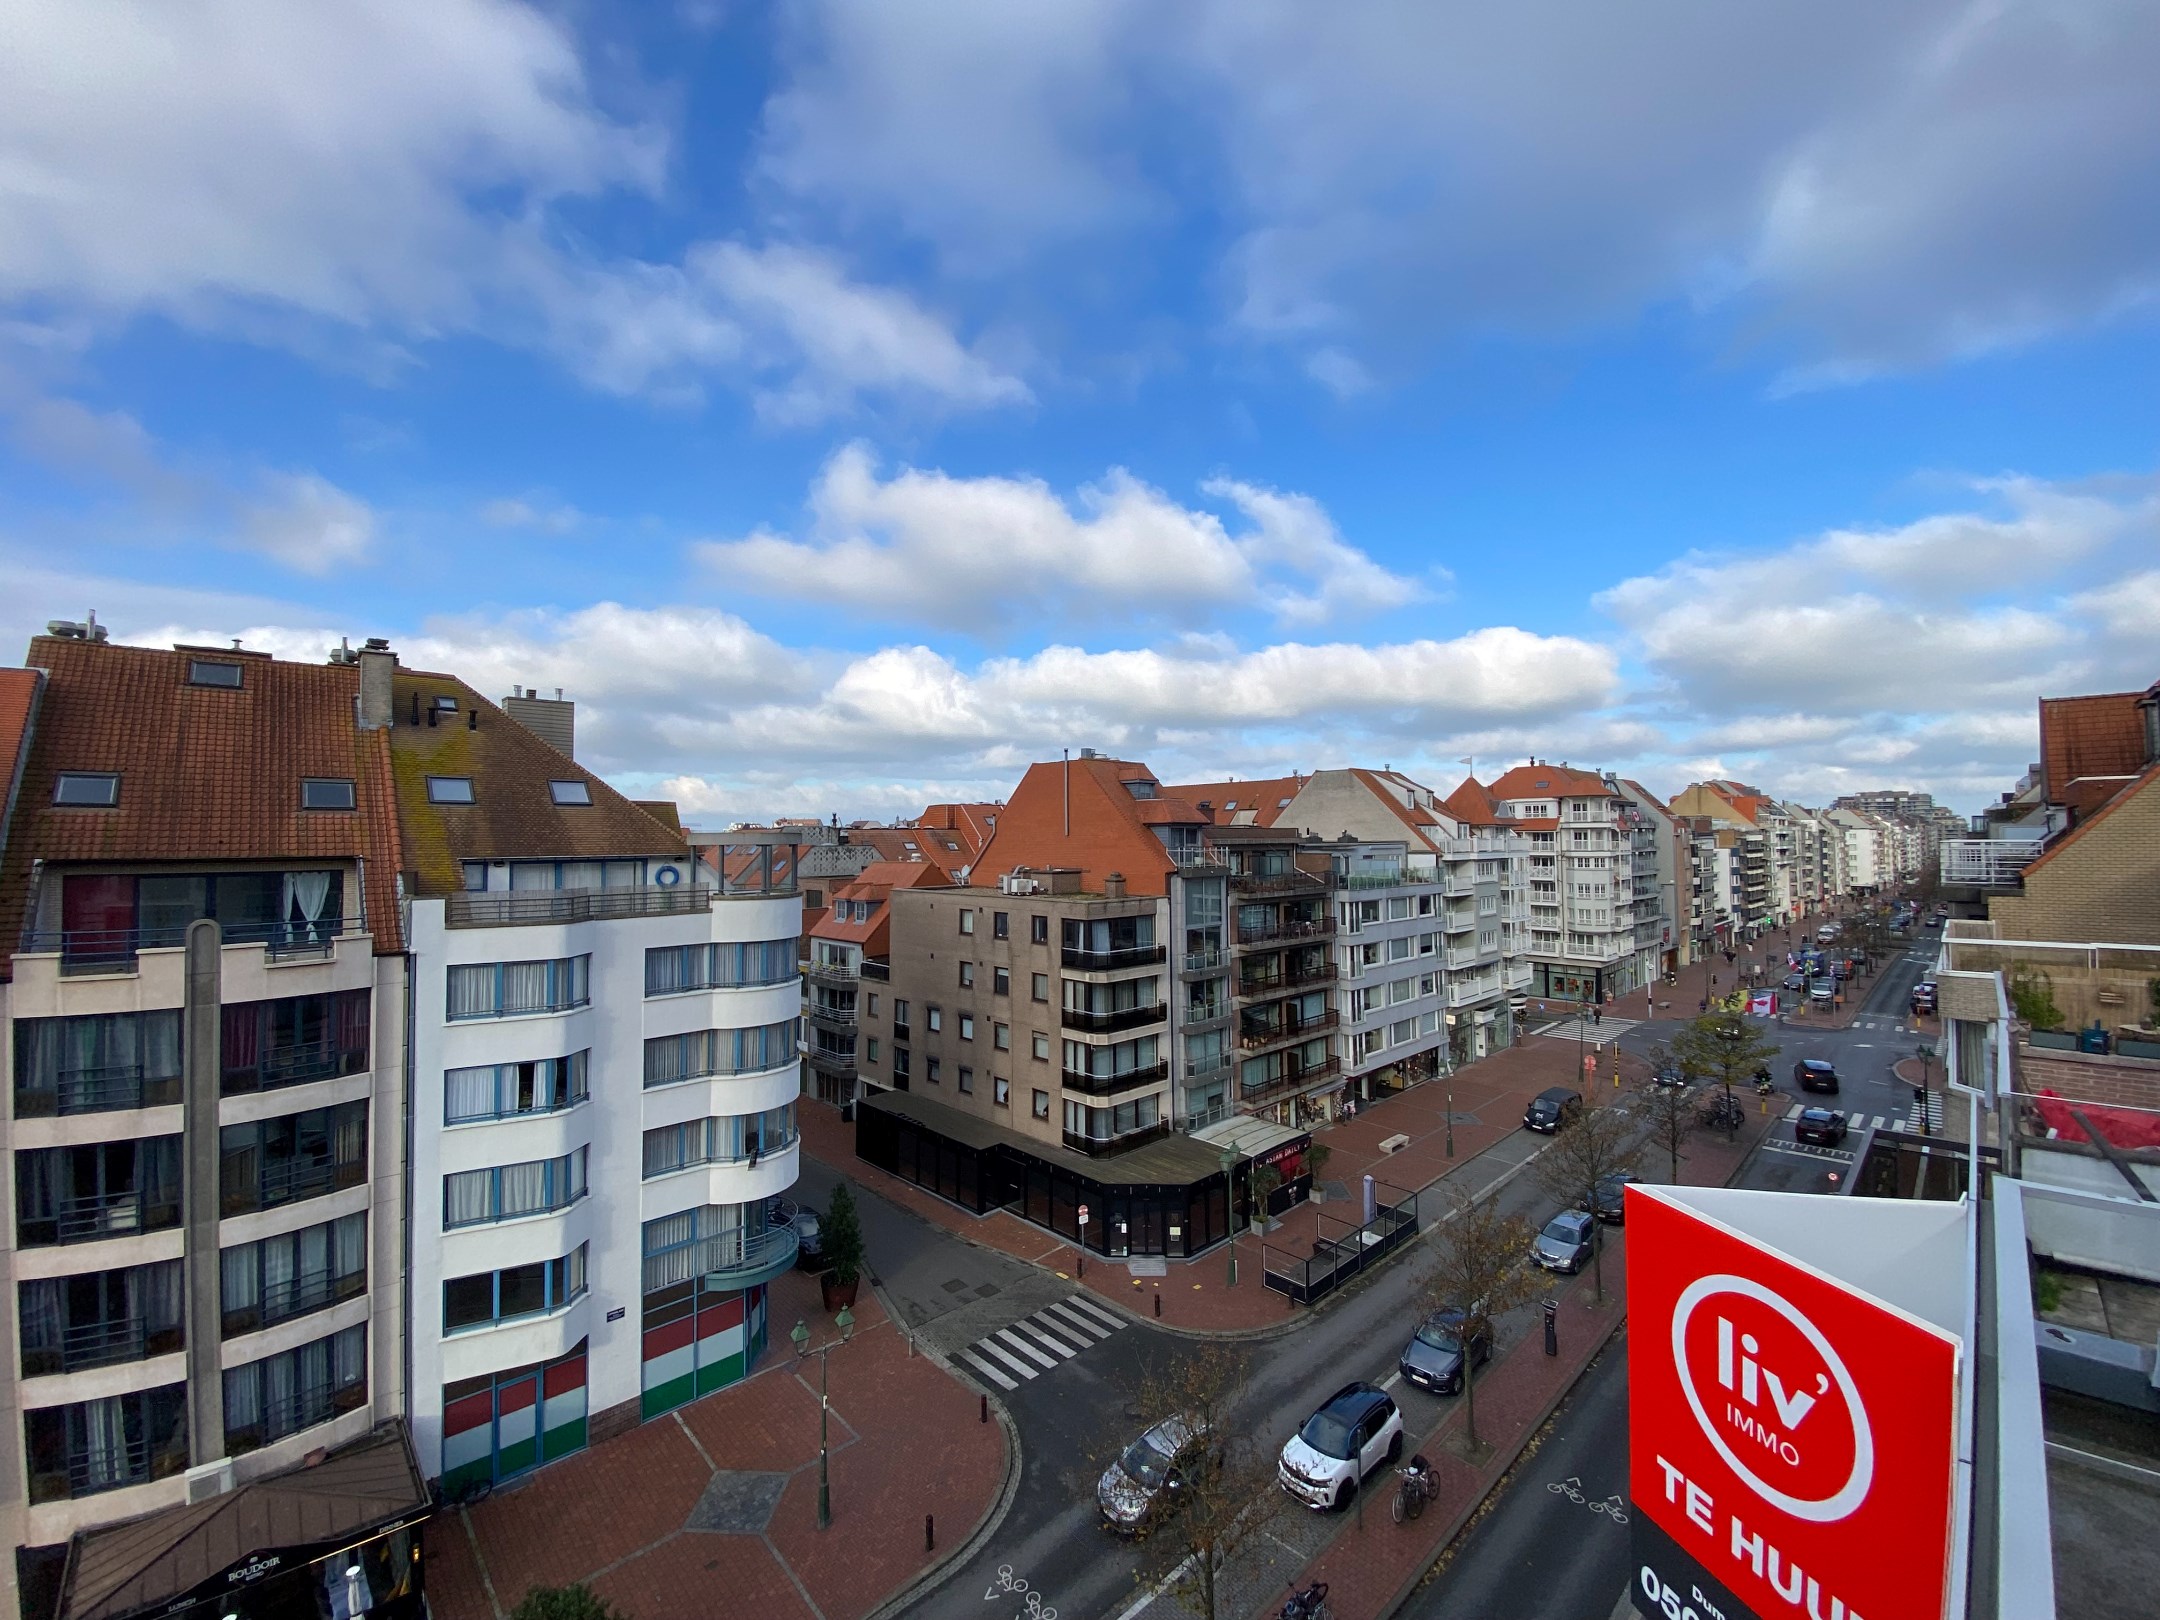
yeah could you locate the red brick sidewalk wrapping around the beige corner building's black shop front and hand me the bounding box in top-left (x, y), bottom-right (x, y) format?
top-left (795, 1037), bottom-right (1646, 1333)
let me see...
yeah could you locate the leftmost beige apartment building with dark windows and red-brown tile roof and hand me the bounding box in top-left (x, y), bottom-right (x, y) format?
top-left (0, 622), bottom-right (428, 1616)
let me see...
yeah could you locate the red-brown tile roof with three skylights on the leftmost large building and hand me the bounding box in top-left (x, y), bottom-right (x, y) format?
top-left (0, 635), bottom-right (402, 976)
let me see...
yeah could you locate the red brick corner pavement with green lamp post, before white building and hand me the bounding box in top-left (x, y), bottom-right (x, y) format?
top-left (428, 1272), bottom-right (1007, 1620)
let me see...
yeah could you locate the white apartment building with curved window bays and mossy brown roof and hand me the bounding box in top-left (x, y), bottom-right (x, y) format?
top-left (388, 650), bottom-right (801, 1493)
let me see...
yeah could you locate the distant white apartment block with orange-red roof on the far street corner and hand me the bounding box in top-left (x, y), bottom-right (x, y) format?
top-left (1482, 760), bottom-right (1661, 1002)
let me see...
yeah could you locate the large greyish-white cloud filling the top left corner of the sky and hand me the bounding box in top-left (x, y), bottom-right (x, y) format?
top-left (0, 0), bottom-right (1026, 419)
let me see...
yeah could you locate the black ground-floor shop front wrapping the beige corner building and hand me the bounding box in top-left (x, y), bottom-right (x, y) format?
top-left (855, 1091), bottom-right (1251, 1259)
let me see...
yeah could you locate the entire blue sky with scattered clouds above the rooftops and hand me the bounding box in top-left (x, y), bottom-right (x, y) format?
top-left (0, 0), bottom-right (2160, 823)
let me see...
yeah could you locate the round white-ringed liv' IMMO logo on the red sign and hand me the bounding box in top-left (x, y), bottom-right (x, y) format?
top-left (1672, 1274), bottom-right (1875, 1523)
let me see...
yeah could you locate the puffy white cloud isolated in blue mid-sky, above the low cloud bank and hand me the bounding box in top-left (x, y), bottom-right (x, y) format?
top-left (698, 445), bottom-right (1423, 637)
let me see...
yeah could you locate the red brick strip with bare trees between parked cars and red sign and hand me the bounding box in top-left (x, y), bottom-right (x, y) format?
top-left (1255, 1119), bottom-right (1767, 1620)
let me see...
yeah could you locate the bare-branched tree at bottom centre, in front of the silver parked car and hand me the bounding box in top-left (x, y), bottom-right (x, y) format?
top-left (1106, 1344), bottom-right (1287, 1620)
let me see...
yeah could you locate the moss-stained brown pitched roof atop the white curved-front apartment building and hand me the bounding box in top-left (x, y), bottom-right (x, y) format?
top-left (378, 670), bottom-right (689, 894)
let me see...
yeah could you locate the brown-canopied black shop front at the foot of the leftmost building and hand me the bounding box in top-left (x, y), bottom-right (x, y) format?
top-left (54, 1421), bottom-right (432, 1620)
